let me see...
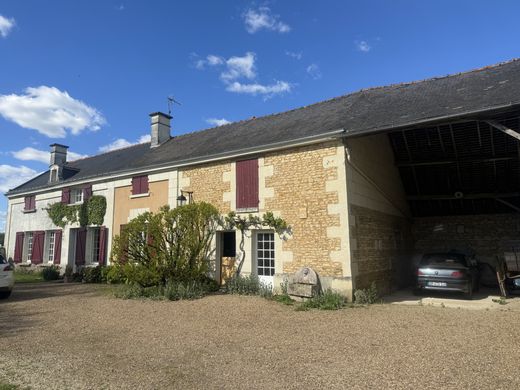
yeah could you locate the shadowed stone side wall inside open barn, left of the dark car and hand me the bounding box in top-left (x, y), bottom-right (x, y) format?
top-left (347, 134), bottom-right (413, 293)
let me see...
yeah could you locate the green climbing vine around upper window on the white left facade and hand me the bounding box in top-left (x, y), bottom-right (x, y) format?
top-left (47, 195), bottom-right (107, 229)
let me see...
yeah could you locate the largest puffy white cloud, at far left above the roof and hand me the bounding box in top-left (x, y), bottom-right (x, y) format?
top-left (0, 86), bottom-right (105, 138)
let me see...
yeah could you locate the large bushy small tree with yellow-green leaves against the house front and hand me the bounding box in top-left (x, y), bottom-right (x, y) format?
top-left (111, 202), bottom-right (220, 285)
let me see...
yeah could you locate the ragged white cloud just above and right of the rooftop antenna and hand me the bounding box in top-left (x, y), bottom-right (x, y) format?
top-left (195, 52), bottom-right (291, 98)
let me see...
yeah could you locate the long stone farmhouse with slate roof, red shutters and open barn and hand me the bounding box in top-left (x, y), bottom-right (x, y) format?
top-left (5, 60), bottom-right (520, 296)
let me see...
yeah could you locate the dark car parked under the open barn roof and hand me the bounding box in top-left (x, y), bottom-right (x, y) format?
top-left (414, 252), bottom-right (479, 299)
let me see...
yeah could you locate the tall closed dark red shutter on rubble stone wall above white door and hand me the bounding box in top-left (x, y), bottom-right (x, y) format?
top-left (236, 159), bottom-right (258, 209)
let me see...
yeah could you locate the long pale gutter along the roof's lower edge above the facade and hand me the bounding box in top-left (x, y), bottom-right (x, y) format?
top-left (4, 129), bottom-right (345, 199)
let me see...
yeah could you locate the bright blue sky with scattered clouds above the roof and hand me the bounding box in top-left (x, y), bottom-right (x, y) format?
top-left (0, 0), bottom-right (520, 231)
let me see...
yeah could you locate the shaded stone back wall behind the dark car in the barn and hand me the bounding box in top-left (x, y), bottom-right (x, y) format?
top-left (413, 214), bottom-right (520, 264)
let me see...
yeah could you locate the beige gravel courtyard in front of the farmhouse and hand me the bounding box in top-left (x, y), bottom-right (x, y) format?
top-left (0, 284), bottom-right (520, 389)
